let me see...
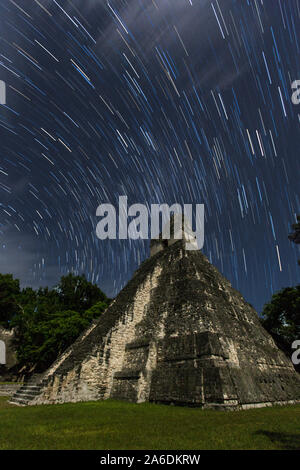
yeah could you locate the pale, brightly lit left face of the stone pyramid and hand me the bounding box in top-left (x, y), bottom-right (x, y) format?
top-left (35, 266), bottom-right (161, 403)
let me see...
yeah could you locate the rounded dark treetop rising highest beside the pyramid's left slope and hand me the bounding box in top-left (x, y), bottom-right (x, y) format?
top-left (55, 273), bottom-right (108, 313)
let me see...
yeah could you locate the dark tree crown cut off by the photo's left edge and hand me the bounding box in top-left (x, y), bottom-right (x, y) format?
top-left (0, 274), bottom-right (20, 328)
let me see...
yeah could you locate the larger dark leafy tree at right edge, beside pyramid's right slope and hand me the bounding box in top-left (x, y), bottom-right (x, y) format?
top-left (261, 285), bottom-right (300, 372)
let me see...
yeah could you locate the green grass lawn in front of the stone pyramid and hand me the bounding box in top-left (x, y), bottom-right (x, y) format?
top-left (0, 397), bottom-right (300, 450)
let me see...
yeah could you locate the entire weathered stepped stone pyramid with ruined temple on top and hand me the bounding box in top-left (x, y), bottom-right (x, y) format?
top-left (12, 217), bottom-right (300, 409)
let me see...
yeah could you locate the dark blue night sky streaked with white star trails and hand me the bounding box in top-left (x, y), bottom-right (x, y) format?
top-left (0, 0), bottom-right (300, 312)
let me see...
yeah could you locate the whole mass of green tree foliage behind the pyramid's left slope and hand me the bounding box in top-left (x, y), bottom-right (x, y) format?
top-left (11, 274), bottom-right (109, 372)
